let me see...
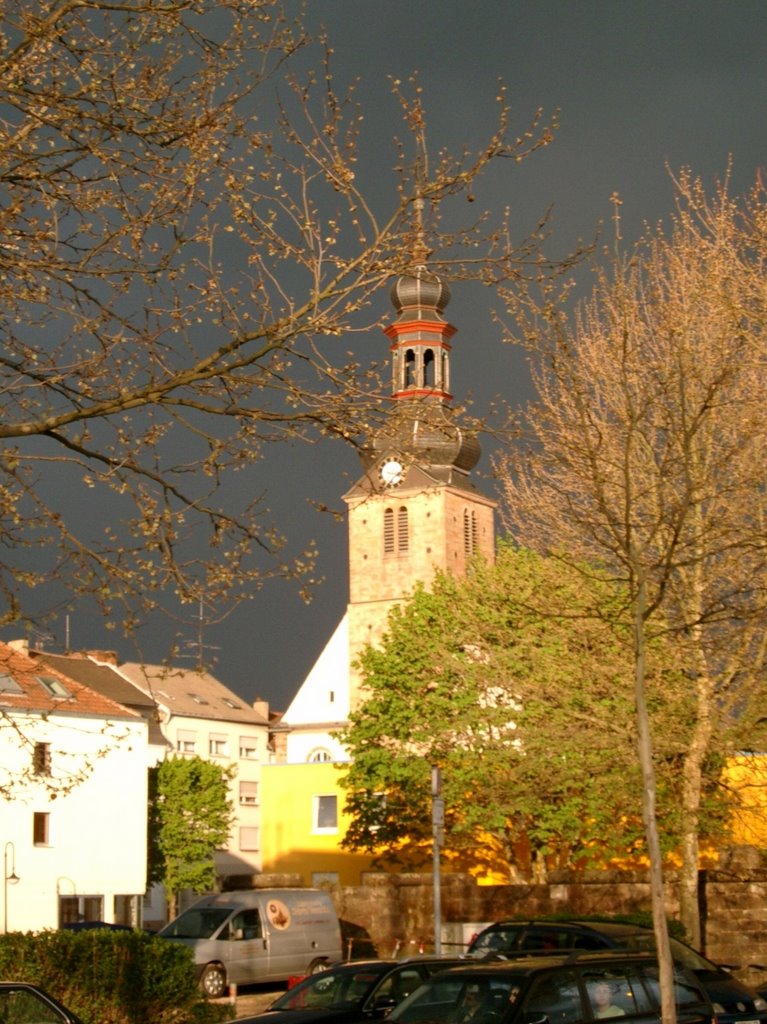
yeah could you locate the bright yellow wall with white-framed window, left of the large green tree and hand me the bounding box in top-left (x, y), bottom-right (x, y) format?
top-left (260, 762), bottom-right (375, 886)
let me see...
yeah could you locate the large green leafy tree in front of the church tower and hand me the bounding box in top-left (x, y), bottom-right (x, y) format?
top-left (343, 545), bottom-right (716, 879)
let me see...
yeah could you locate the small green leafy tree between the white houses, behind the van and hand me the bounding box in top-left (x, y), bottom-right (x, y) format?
top-left (148, 757), bottom-right (233, 916)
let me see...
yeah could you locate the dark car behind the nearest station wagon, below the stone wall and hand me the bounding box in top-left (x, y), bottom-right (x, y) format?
top-left (460, 921), bottom-right (767, 1024)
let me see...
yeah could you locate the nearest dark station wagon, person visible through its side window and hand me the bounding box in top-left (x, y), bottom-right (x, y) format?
top-left (387, 951), bottom-right (716, 1024)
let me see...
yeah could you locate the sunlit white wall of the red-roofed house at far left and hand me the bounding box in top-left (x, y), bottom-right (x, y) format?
top-left (0, 711), bottom-right (147, 931)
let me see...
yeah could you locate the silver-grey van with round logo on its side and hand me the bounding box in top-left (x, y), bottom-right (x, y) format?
top-left (159, 889), bottom-right (343, 998)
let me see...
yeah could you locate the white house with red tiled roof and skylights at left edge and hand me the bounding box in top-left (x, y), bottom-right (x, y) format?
top-left (0, 644), bottom-right (147, 932)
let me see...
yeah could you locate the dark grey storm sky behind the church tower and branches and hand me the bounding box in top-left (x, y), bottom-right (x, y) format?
top-left (37, 0), bottom-right (767, 709)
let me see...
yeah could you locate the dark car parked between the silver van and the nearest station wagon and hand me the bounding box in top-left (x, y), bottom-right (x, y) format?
top-left (238, 956), bottom-right (465, 1024)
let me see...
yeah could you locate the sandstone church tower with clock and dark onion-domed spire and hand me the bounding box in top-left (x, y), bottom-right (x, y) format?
top-left (344, 265), bottom-right (496, 709)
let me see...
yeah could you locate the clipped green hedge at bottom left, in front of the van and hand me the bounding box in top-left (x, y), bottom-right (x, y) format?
top-left (0, 929), bottom-right (227, 1024)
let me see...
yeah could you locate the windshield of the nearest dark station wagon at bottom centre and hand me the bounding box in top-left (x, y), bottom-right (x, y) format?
top-left (387, 971), bottom-right (524, 1024)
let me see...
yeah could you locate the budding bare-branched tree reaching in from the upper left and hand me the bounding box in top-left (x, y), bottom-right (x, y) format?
top-left (0, 0), bottom-right (573, 647)
